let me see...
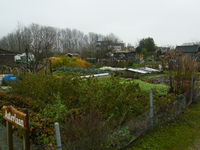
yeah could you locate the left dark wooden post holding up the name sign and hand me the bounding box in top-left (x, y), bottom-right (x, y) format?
top-left (5, 102), bottom-right (13, 150)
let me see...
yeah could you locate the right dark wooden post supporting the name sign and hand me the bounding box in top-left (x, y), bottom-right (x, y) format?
top-left (22, 108), bottom-right (30, 150)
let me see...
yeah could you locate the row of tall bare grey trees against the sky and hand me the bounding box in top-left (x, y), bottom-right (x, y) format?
top-left (0, 22), bottom-right (124, 64)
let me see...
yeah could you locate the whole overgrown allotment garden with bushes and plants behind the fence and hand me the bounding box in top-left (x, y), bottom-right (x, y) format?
top-left (0, 54), bottom-right (197, 149)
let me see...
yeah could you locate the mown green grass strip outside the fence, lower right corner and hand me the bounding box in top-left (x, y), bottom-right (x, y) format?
top-left (126, 103), bottom-right (200, 150)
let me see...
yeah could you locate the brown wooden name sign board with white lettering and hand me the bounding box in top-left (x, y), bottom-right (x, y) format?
top-left (2, 106), bottom-right (26, 130)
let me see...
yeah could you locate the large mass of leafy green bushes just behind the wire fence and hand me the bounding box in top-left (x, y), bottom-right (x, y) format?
top-left (2, 73), bottom-right (177, 144)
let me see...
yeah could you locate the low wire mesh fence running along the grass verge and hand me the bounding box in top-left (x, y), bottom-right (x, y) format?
top-left (0, 87), bottom-right (198, 150)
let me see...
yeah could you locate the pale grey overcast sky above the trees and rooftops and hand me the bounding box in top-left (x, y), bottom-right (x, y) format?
top-left (0, 0), bottom-right (200, 46)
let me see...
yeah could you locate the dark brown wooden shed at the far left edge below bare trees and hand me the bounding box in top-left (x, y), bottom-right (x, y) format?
top-left (0, 48), bottom-right (15, 65)
